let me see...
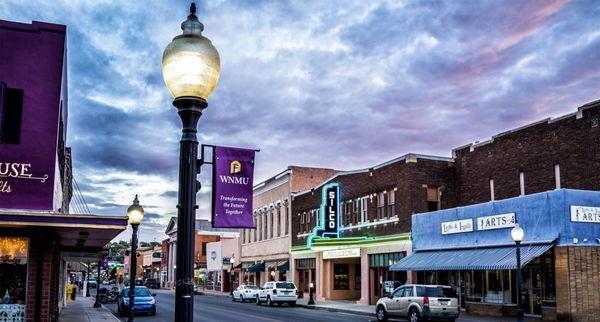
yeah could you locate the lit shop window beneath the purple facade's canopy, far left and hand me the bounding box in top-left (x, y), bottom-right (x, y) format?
top-left (0, 237), bottom-right (29, 321)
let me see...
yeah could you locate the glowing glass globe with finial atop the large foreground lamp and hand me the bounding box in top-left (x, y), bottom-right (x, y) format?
top-left (162, 3), bottom-right (221, 100)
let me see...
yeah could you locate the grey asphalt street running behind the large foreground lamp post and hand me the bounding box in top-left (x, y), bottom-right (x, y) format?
top-left (105, 290), bottom-right (376, 322)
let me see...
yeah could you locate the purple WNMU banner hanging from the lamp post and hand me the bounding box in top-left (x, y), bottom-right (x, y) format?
top-left (212, 146), bottom-right (255, 228)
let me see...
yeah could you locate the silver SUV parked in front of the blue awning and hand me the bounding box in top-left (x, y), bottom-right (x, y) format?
top-left (375, 284), bottom-right (460, 322)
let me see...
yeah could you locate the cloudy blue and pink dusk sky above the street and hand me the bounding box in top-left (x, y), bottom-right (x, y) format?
top-left (0, 0), bottom-right (600, 241)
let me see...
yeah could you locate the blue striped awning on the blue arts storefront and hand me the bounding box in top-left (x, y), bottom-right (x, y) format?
top-left (390, 243), bottom-right (554, 271)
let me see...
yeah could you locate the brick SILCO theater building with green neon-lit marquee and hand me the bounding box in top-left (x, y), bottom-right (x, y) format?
top-left (291, 154), bottom-right (452, 304)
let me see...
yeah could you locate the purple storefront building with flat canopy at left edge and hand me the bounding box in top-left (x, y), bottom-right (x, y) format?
top-left (0, 20), bottom-right (127, 321)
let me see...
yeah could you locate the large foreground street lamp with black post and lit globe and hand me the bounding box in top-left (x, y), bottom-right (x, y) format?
top-left (162, 3), bottom-right (221, 322)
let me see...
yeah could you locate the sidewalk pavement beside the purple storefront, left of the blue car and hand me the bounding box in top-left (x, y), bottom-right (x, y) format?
top-left (58, 296), bottom-right (120, 322)
